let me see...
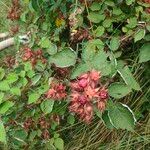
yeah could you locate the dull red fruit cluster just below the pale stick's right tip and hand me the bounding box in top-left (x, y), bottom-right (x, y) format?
top-left (22, 47), bottom-right (46, 66)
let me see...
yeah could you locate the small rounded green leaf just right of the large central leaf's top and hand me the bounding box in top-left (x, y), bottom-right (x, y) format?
top-left (109, 37), bottom-right (120, 51)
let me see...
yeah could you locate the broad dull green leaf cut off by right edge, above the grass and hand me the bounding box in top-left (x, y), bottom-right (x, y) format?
top-left (139, 43), bottom-right (150, 63)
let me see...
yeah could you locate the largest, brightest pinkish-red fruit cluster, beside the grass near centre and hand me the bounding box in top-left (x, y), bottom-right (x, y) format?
top-left (69, 70), bottom-right (108, 123)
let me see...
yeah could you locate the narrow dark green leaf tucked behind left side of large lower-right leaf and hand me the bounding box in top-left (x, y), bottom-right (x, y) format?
top-left (102, 111), bottom-right (114, 129)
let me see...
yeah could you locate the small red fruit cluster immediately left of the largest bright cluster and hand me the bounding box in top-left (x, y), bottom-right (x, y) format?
top-left (46, 83), bottom-right (67, 100)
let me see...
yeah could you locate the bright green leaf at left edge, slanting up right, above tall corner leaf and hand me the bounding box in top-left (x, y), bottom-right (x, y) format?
top-left (0, 101), bottom-right (14, 114)
